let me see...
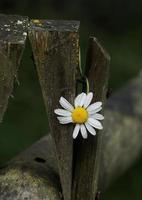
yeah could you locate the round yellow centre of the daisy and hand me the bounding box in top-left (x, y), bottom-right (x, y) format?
top-left (72, 107), bottom-right (88, 124)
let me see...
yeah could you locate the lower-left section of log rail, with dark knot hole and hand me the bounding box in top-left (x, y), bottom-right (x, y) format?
top-left (0, 136), bottom-right (62, 200)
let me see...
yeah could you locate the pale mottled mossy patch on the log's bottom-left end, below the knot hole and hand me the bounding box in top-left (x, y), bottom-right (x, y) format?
top-left (0, 168), bottom-right (60, 200)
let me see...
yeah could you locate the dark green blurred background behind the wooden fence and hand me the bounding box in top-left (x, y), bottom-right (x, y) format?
top-left (0, 0), bottom-right (142, 200)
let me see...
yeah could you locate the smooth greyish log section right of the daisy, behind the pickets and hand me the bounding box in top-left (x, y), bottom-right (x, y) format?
top-left (100, 72), bottom-right (142, 190)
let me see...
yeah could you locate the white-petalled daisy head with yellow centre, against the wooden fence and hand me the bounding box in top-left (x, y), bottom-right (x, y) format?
top-left (54, 92), bottom-right (104, 139)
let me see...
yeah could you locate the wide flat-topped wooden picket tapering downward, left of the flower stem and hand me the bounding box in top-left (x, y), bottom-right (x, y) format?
top-left (29, 20), bottom-right (79, 200)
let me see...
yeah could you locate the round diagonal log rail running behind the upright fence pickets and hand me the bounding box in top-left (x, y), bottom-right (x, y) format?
top-left (0, 75), bottom-right (142, 200)
